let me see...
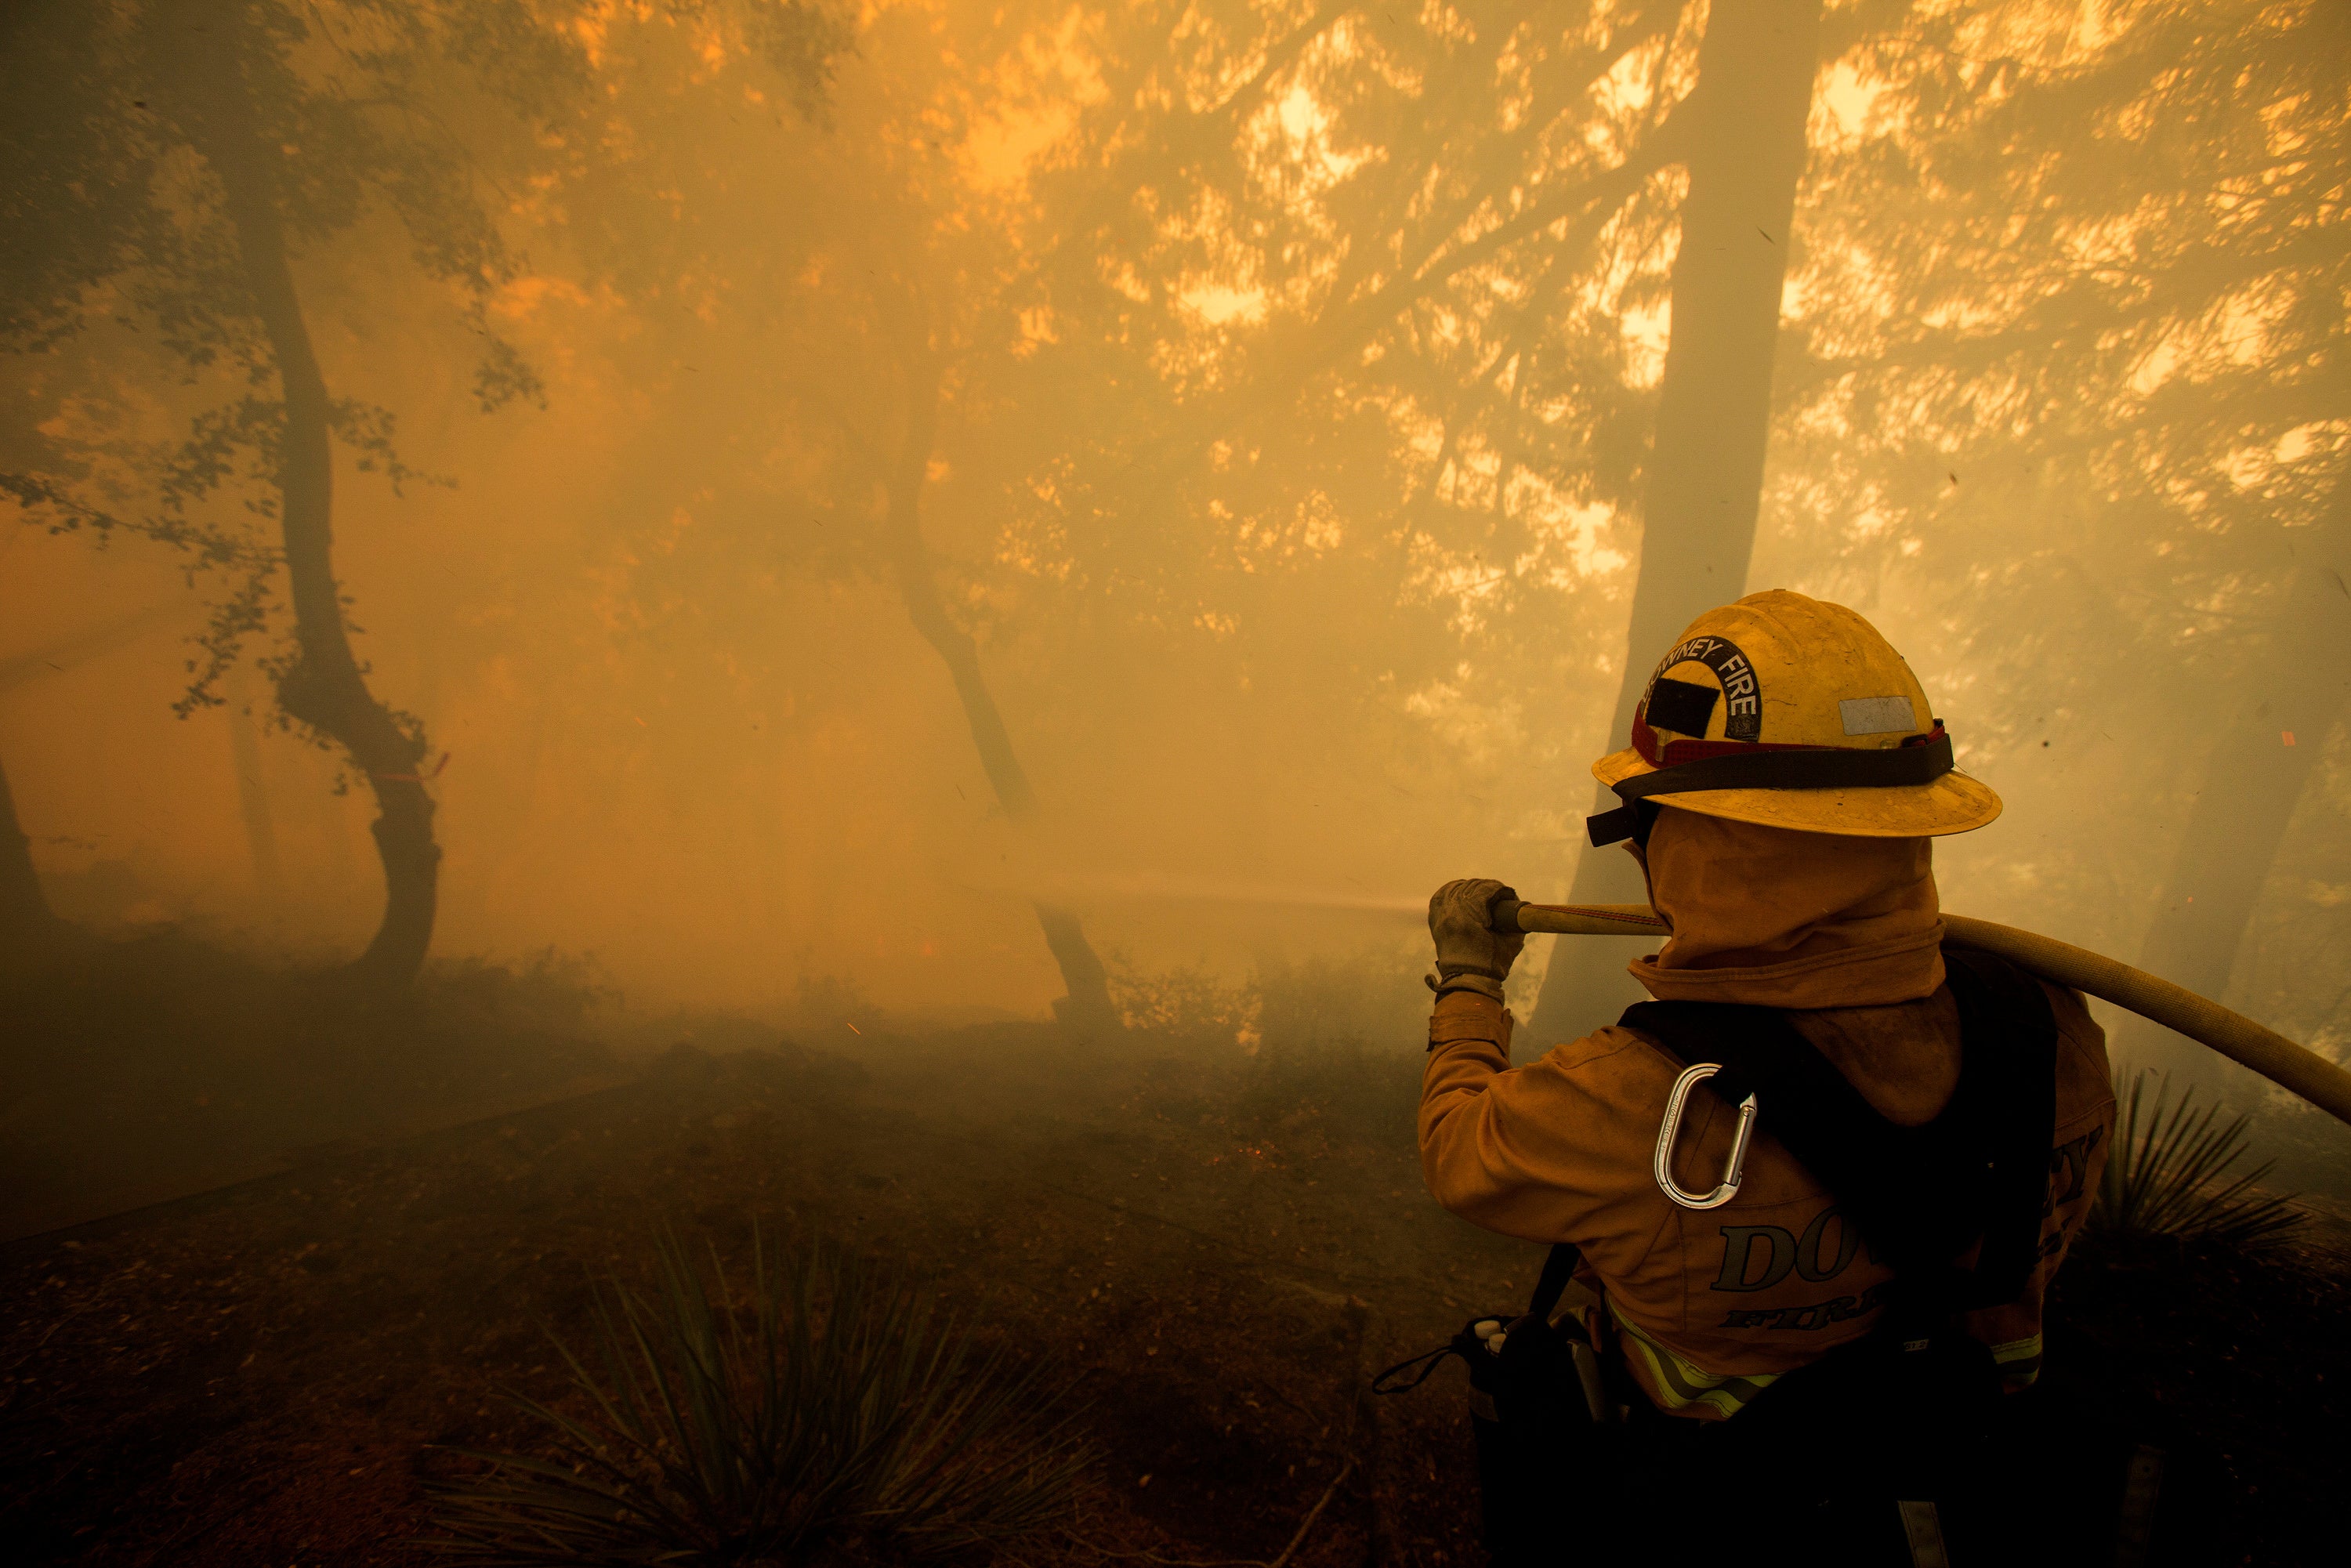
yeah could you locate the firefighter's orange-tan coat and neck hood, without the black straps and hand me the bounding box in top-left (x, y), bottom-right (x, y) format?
top-left (1420, 806), bottom-right (2114, 1420)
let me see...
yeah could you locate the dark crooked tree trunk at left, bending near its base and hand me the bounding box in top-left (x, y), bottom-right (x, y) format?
top-left (183, 31), bottom-right (440, 987)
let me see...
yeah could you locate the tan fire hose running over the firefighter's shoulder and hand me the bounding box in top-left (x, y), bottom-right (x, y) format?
top-left (1493, 900), bottom-right (2351, 1124)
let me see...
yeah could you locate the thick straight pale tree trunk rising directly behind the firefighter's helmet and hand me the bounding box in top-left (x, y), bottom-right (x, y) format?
top-left (1531, 0), bottom-right (1820, 1046)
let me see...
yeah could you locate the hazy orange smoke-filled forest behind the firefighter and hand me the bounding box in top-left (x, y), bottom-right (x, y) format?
top-left (0, 0), bottom-right (2351, 1114)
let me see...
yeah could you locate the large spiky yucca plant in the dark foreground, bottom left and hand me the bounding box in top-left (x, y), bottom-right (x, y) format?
top-left (433, 1232), bottom-right (1086, 1568)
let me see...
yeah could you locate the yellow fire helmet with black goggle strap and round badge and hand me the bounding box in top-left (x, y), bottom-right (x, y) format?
top-left (1585, 588), bottom-right (2001, 844)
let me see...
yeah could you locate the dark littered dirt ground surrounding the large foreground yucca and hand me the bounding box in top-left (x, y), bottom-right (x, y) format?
top-left (0, 1027), bottom-right (2351, 1568)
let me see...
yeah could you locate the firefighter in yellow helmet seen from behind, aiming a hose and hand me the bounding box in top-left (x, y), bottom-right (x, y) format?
top-left (1420, 590), bottom-right (2114, 1561)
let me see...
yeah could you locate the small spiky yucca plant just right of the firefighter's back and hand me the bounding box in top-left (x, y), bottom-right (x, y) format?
top-left (2088, 1070), bottom-right (2302, 1246)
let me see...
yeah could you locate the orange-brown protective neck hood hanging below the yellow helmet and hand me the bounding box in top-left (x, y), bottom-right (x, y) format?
top-left (1632, 806), bottom-right (1942, 1009)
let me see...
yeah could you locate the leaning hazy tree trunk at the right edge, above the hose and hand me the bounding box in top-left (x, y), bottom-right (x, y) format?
top-left (2116, 480), bottom-right (2351, 1098)
